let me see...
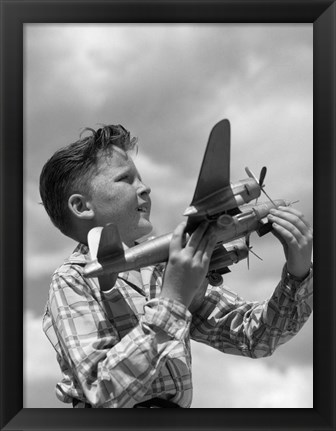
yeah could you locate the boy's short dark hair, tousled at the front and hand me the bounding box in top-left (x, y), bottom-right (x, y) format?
top-left (40, 124), bottom-right (137, 236)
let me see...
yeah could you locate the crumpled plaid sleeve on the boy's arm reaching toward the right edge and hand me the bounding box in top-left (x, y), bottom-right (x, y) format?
top-left (190, 266), bottom-right (313, 358)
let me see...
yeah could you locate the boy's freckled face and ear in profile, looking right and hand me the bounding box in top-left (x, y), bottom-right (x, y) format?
top-left (88, 148), bottom-right (152, 247)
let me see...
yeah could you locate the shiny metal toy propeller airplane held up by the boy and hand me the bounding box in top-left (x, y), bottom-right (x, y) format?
top-left (84, 120), bottom-right (288, 285)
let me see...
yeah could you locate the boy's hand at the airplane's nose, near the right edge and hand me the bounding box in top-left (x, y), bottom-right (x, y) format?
top-left (268, 207), bottom-right (313, 279)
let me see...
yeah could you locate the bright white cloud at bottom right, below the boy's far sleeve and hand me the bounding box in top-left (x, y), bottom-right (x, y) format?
top-left (192, 342), bottom-right (313, 408)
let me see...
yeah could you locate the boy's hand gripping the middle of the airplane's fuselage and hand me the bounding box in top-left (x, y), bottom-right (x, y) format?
top-left (160, 222), bottom-right (216, 307)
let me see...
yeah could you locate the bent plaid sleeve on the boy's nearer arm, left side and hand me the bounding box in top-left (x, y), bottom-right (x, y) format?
top-left (49, 274), bottom-right (191, 407)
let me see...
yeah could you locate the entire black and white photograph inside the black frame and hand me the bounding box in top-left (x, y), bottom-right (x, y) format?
top-left (23, 23), bottom-right (314, 409)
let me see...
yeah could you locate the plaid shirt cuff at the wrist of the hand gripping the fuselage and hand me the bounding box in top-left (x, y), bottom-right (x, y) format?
top-left (142, 298), bottom-right (191, 340)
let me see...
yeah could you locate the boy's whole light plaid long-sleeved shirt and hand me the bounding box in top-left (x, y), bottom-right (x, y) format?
top-left (43, 245), bottom-right (312, 408)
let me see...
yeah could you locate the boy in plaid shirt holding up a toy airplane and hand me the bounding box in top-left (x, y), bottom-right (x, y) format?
top-left (40, 125), bottom-right (312, 408)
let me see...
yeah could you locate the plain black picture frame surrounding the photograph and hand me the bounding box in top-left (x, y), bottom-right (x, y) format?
top-left (0, 0), bottom-right (336, 431)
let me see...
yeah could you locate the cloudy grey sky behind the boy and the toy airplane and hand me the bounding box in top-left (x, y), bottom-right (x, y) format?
top-left (24, 24), bottom-right (313, 408)
